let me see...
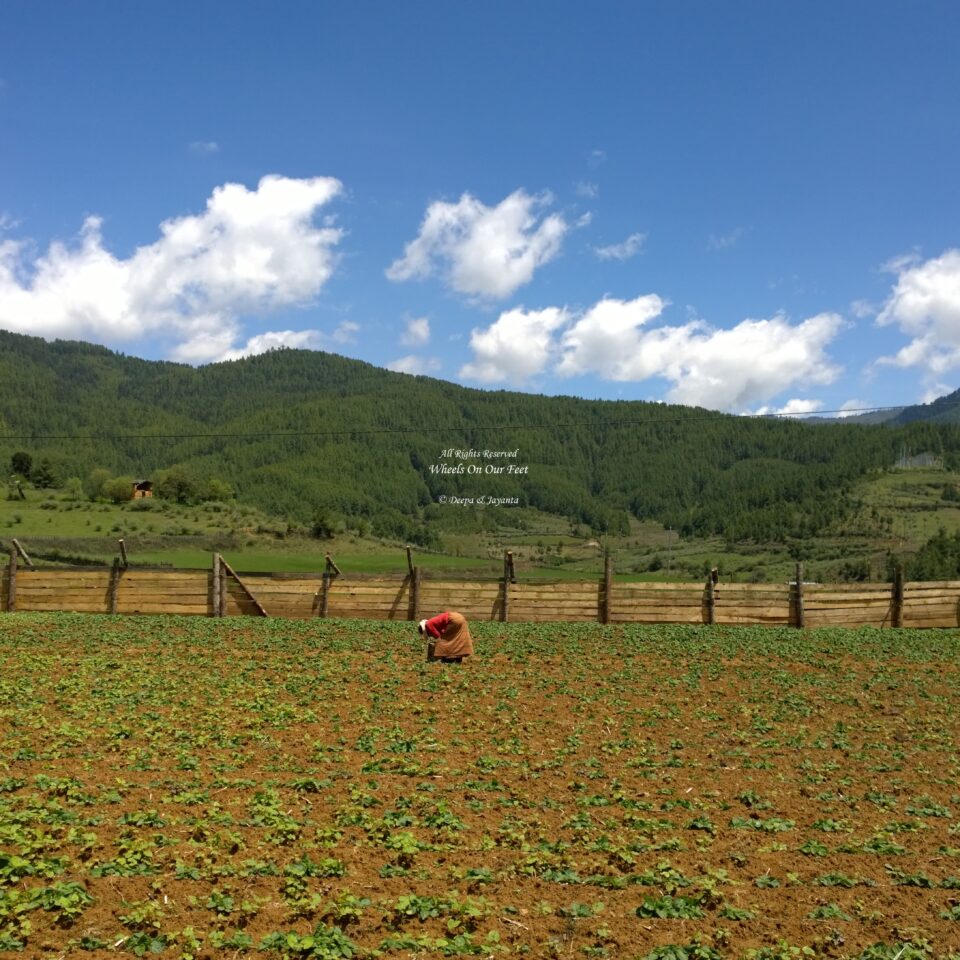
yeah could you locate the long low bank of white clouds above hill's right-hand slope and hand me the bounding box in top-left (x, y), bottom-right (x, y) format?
top-left (460, 294), bottom-right (843, 412)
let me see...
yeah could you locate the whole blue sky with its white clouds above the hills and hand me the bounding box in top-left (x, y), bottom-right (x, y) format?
top-left (0, 0), bottom-right (960, 412)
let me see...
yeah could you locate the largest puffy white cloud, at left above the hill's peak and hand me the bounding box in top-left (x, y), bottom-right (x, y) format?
top-left (0, 176), bottom-right (341, 363)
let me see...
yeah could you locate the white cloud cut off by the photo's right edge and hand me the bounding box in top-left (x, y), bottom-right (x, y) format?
top-left (876, 249), bottom-right (960, 378)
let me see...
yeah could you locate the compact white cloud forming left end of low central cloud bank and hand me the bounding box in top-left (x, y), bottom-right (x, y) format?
top-left (460, 307), bottom-right (569, 384)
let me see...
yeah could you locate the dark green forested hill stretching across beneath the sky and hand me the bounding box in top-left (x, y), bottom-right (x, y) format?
top-left (0, 332), bottom-right (960, 541)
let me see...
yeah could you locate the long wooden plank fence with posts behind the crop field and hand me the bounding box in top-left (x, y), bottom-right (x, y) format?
top-left (0, 551), bottom-right (960, 627)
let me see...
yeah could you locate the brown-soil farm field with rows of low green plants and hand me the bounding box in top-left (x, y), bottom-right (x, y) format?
top-left (0, 614), bottom-right (960, 960)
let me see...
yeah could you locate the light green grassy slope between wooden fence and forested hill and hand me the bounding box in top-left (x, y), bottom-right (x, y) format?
top-left (0, 469), bottom-right (960, 582)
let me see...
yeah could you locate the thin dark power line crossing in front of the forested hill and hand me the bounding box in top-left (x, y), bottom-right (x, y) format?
top-left (0, 400), bottom-right (960, 441)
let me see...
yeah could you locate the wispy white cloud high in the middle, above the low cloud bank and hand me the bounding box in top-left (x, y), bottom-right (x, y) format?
top-left (387, 190), bottom-right (568, 299)
